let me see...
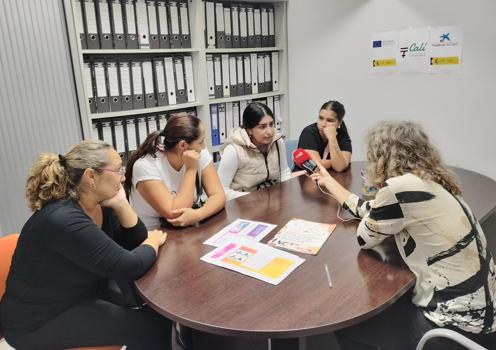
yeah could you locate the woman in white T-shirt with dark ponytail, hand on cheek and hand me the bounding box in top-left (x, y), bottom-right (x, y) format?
top-left (124, 113), bottom-right (226, 229)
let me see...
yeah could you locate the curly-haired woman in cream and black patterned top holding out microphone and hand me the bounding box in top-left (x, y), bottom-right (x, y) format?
top-left (312, 122), bottom-right (496, 349)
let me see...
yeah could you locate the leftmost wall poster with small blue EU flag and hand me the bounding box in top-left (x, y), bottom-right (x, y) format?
top-left (372, 31), bottom-right (399, 73)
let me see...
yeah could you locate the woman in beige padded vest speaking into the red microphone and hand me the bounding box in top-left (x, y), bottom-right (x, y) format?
top-left (219, 102), bottom-right (291, 200)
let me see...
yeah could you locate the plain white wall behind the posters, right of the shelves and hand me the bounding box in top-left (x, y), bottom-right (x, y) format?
top-left (288, 0), bottom-right (496, 179)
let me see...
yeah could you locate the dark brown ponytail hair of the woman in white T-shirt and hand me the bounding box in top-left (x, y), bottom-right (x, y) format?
top-left (124, 113), bottom-right (201, 197)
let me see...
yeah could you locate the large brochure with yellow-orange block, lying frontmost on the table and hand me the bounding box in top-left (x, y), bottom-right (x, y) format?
top-left (201, 238), bottom-right (305, 285)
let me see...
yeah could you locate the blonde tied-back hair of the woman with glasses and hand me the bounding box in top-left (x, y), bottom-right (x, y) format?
top-left (26, 140), bottom-right (112, 211)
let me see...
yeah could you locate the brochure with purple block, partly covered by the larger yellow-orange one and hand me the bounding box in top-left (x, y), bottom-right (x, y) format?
top-left (203, 219), bottom-right (276, 247)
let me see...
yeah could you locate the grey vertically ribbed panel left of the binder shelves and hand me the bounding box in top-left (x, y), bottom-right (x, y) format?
top-left (0, 0), bottom-right (82, 235)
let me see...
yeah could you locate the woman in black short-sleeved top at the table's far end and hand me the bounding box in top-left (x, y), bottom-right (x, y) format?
top-left (293, 101), bottom-right (351, 171)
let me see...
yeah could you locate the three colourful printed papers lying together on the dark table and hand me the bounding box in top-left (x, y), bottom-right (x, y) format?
top-left (201, 219), bottom-right (336, 285)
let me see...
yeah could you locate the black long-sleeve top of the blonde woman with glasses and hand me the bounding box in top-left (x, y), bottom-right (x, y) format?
top-left (0, 200), bottom-right (156, 336)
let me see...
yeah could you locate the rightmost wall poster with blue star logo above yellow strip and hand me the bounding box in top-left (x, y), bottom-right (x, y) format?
top-left (429, 25), bottom-right (463, 74)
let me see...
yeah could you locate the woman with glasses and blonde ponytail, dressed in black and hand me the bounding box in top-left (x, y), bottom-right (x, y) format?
top-left (0, 141), bottom-right (171, 350)
